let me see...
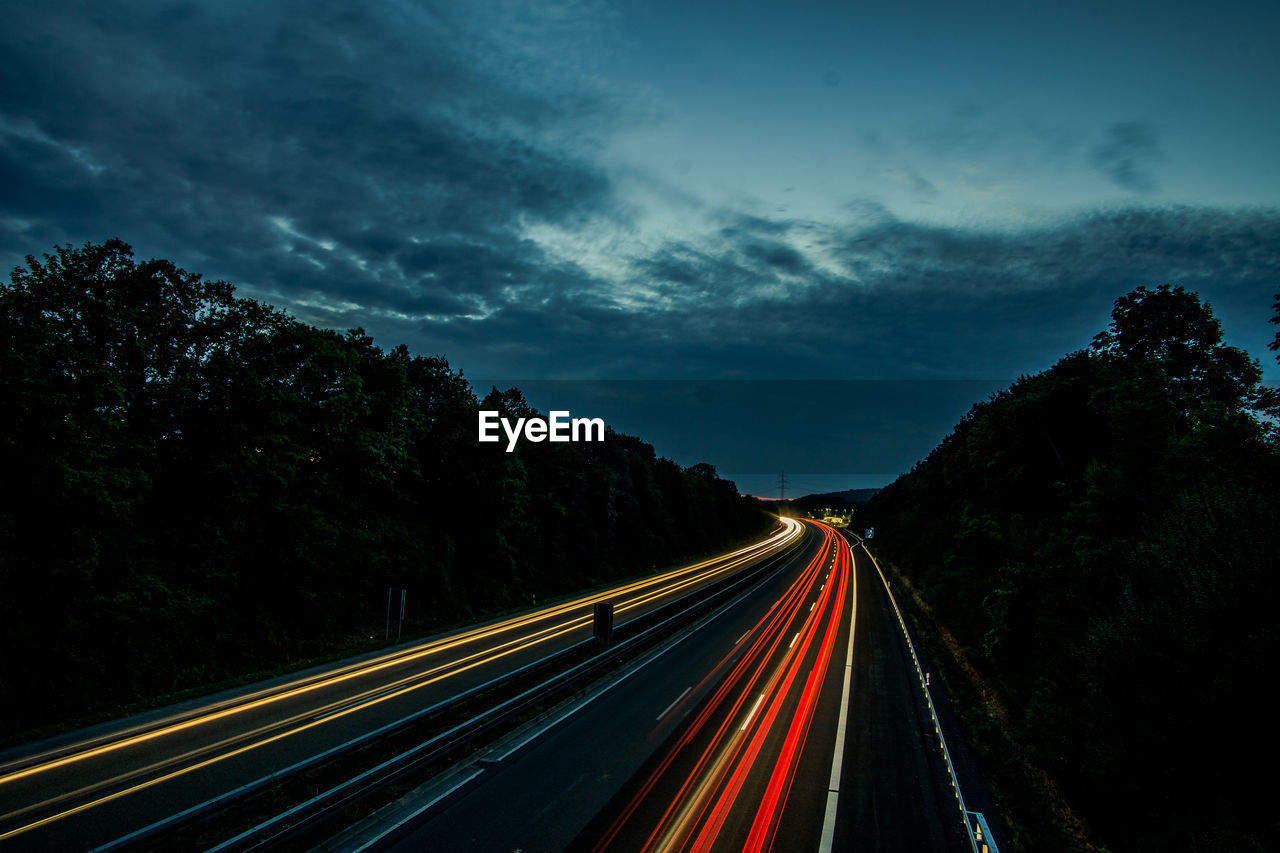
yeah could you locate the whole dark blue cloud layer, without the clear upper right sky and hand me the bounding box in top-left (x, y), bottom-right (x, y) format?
top-left (0, 0), bottom-right (1280, 389)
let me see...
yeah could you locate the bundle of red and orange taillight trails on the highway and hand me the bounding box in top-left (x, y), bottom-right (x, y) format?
top-left (590, 517), bottom-right (852, 850)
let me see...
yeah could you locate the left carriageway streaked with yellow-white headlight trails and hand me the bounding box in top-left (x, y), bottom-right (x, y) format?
top-left (0, 520), bottom-right (803, 850)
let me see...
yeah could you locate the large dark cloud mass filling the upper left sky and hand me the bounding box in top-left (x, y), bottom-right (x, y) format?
top-left (0, 0), bottom-right (621, 322)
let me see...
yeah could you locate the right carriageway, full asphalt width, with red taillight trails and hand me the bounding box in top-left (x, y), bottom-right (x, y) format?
top-left (360, 523), bottom-right (970, 853)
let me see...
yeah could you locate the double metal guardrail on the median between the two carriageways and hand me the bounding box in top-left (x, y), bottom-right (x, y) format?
top-left (92, 527), bottom-right (804, 853)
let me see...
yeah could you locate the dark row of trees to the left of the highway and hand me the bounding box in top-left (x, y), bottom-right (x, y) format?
top-left (0, 241), bottom-right (769, 736)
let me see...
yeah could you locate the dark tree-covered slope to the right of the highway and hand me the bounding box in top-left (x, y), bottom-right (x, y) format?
top-left (863, 286), bottom-right (1280, 850)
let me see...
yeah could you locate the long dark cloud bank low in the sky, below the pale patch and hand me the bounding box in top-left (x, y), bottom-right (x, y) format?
top-left (350, 201), bottom-right (1280, 379)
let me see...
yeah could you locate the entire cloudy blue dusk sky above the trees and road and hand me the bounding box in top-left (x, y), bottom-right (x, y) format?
top-left (0, 0), bottom-right (1280, 493)
